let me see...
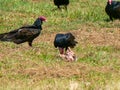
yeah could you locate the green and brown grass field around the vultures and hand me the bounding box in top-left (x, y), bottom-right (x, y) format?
top-left (0, 0), bottom-right (120, 90)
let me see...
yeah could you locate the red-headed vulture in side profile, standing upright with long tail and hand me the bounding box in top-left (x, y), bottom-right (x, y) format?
top-left (0, 16), bottom-right (46, 46)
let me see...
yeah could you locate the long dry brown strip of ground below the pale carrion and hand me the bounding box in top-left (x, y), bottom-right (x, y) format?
top-left (18, 63), bottom-right (115, 81)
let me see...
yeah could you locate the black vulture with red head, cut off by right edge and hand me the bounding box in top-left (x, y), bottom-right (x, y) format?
top-left (105, 0), bottom-right (120, 21)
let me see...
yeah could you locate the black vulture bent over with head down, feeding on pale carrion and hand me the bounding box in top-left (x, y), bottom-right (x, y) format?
top-left (54, 33), bottom-right (77, 54)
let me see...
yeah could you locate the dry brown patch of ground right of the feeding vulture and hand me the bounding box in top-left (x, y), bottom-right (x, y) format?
top-left (73, 27), bottom-right (120, 47)
